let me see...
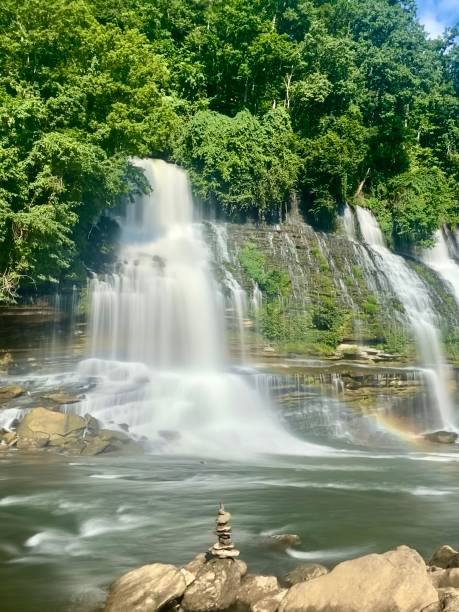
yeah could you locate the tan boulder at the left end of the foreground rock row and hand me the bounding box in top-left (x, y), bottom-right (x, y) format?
top-left (105, 563), bottom-right (186, 612)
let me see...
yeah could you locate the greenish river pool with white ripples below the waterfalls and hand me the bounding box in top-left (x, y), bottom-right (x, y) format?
top-left (0, 448), bottom-right (459, 612)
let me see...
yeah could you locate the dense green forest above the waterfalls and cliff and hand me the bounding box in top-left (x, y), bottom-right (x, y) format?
top-left (0, 0), bottom-right (459, 302)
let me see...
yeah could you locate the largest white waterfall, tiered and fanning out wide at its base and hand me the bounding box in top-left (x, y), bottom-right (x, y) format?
top-left (78, 160), bottom-right (325, 457)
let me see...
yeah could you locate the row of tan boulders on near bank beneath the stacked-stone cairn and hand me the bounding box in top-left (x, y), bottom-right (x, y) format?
top-left (104, 546), bottom-right (459, 612)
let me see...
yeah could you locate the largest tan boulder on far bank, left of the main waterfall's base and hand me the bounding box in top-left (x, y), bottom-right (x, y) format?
top-left (16, 408), bottom-right (86, 438)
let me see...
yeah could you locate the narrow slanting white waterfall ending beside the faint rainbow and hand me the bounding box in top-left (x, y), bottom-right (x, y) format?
top-left (356, 206), bottom-right (454, 427)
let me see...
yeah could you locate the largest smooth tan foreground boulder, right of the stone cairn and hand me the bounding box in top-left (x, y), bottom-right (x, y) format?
top-left (279, 546), bottom-right (440, 612)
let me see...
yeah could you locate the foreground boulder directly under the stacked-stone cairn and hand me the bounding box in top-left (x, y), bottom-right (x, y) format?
top-left (182, 559), bottom-right (241, 612)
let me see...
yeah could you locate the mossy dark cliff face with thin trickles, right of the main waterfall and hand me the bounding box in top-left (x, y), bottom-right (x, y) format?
top-left (207, 218), bottom-right (459, 362)
